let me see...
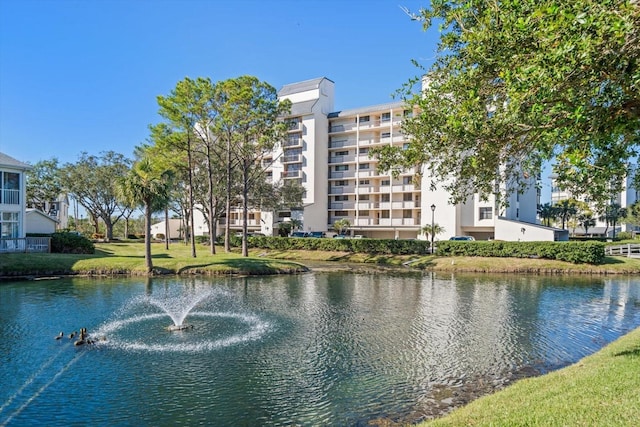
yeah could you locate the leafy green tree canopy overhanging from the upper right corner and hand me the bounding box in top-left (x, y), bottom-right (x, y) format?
top-left (378, 0), bottom-right (640, 206)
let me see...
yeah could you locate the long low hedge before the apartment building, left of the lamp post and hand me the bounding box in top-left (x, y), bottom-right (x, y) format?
top-left (249, 236), bottom-right (429, 255)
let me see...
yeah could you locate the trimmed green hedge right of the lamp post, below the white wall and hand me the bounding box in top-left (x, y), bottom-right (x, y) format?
top-left (436, 240), bottom-right (605, 264)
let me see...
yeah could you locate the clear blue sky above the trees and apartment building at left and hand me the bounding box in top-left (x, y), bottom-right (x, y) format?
top-left (0, 0), bottom-right (437, 164)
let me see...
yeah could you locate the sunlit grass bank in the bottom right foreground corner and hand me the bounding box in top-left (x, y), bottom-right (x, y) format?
top-left (420, 329), bottom-right (640, 427)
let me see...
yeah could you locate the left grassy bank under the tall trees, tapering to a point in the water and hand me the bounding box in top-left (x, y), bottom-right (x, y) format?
top-left (0, 242), bottom-right (306, 277)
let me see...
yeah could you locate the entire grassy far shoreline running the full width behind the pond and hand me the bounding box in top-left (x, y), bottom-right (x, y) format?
top-left (0, 242), bottom-right (640, 278)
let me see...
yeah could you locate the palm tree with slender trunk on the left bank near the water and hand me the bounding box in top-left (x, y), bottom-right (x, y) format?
top-left (118, 157), bottom-right (172, 273)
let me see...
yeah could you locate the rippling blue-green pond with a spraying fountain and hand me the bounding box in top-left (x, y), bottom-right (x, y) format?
top-left (0, 272), bottom-right (640, 426)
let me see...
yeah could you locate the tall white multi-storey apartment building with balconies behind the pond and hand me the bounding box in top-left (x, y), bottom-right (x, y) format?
top-left (190, 77), bottom-right (568, 241)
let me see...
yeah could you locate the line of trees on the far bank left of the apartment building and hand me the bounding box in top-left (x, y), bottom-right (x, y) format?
top-left (27, 76), bottom-right (304, 271)
